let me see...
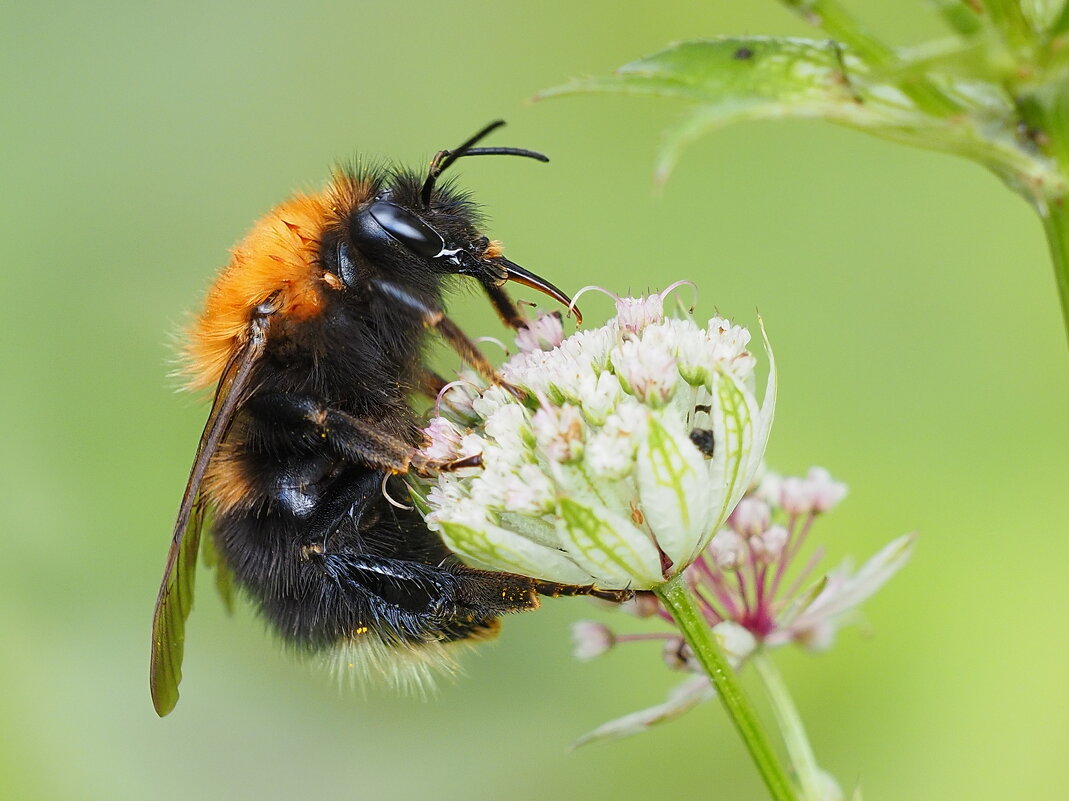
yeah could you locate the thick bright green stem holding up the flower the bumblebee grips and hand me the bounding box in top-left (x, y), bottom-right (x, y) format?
top-left (654, 575), bottom-right (799, 801)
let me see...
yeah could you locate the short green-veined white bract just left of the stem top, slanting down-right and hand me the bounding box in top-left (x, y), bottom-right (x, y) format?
top-left (557, 497), bottom-right (664, 589)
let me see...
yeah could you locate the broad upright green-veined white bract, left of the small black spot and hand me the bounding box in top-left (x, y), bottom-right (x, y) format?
top-left (635, 413), bottom-right (714, 572)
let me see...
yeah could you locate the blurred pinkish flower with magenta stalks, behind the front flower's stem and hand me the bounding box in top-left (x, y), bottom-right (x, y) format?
top-left (575, 467), bottom-right (915, 743)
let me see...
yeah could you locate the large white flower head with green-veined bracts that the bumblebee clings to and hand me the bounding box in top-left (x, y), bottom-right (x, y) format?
top-left (412, 286), bottom-right (775, 589)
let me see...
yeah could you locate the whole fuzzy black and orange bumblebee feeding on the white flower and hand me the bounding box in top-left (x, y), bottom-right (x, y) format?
top-left (150, 121), bottom-right (628, 715)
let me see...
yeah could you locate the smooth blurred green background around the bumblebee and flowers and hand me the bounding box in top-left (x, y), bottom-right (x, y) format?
top-left (0, 0), bottom-right (1069, 801)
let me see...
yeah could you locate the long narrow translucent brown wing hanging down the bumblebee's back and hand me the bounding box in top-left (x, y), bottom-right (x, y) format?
top-left (149, 304), bottom-right (274, 718)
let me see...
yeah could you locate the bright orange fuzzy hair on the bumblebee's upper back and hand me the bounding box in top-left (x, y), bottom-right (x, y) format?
top-left (183, 189), bottom-right (337, 389)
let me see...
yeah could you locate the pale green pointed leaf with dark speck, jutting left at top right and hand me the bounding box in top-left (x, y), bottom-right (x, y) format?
top-left (538, 36), bottom-right (1066, 199)
